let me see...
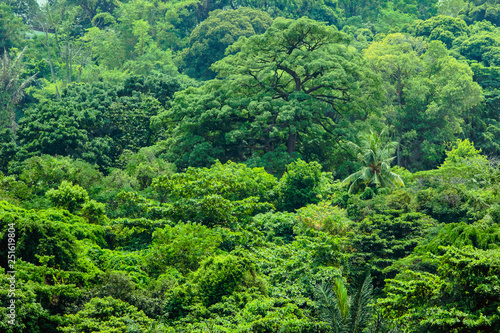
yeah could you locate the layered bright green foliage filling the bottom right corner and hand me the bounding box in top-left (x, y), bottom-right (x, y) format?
top-left (378, 247), bottom-right (500, 332)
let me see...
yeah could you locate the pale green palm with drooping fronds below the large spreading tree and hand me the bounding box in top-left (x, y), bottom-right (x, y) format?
top-left (341, 131), bottom-right (405, 193)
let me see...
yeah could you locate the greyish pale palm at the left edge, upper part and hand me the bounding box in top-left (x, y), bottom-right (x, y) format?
top-left (0, 47), bottom-right (36, 130)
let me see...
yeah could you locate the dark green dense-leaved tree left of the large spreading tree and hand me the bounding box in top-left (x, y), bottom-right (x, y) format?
top-left (18, 77), bottom-right (188, 170)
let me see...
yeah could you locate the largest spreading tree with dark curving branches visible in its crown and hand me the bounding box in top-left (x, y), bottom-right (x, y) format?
top-left (155, 18), bottom-right (379, 167)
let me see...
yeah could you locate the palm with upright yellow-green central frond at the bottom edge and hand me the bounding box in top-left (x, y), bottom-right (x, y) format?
top-left (315, 275), bottom-right (373, 333)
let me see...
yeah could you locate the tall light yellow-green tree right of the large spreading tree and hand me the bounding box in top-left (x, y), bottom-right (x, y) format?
top-left (365, 34), bottom-right (481, 171)
